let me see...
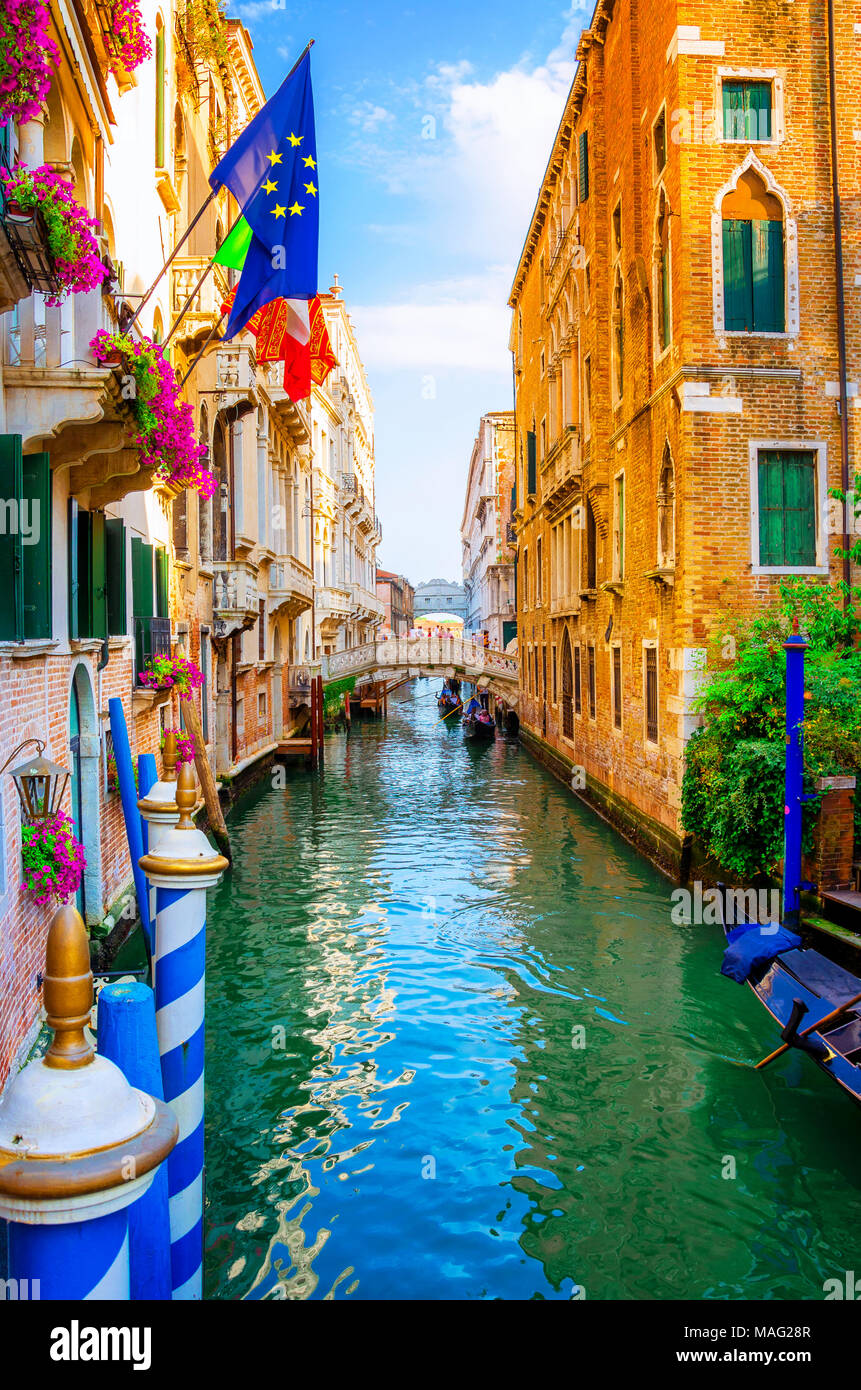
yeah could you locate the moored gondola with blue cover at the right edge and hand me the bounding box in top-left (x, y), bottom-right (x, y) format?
top-left (722, 895), bottom-right (861, 1105)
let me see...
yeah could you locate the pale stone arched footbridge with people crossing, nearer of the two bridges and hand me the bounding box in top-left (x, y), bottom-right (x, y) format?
top-left (320, 637), bottom-right (517, 709)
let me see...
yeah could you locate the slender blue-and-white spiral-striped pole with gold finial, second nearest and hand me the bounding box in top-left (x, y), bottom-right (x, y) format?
top-left (140, 763), bottom-right (228, 1298)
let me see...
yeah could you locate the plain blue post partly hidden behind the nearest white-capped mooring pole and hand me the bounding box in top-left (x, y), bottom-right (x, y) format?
top-left (99, 980), bottom-right (171, 1301)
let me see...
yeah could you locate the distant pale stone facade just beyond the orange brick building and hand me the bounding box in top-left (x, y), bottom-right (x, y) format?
top-left (460, 410), bottom-right (517, 652)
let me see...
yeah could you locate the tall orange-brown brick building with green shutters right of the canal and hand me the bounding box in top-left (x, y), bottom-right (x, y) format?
top-left (510, 0), bottom-right (861, 863)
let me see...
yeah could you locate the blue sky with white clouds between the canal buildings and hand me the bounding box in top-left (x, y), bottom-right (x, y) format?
top-left (239, 0), bottom-right (593, 584)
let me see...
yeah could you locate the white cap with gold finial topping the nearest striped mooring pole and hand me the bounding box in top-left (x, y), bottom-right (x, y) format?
top-left (0, 906), bottom-right (178, 1225)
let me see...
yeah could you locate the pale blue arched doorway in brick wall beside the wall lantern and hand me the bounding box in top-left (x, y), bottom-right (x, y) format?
top-left (68, 663), bottom-right (103, 923)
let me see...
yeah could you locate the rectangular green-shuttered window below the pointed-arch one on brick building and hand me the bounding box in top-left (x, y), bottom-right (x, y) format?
top-left (757, 449), bottom-right (816, 570)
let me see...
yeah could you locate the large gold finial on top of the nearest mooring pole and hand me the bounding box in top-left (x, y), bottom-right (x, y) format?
top-left (43, 905), bottom-right (95, 1070)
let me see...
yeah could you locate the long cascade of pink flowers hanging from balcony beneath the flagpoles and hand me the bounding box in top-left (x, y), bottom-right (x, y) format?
top-left (90, 328), bottom-right (216, 498)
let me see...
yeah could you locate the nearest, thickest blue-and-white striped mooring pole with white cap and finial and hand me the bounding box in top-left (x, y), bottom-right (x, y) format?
top-left (0, 906), bottom-right (177, 1300)
